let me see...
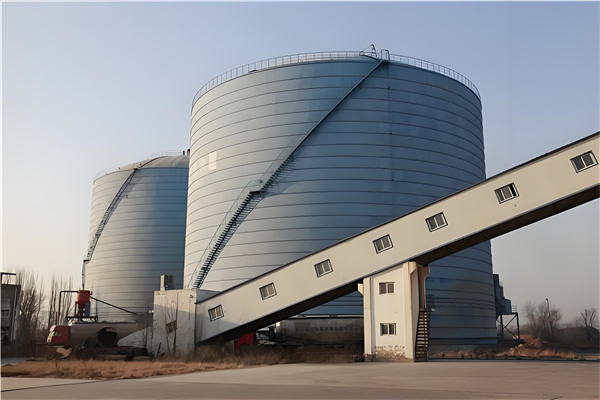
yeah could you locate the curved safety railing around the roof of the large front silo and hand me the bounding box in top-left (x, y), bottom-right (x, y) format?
top-left (192, 49), bottom-right (481, 107)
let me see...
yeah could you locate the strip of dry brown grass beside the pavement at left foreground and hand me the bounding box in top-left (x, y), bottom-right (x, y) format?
top-left (2, 360), bottom-right (243, 379)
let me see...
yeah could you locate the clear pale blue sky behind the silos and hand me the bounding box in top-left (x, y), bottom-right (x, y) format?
top-left (2, 2), bottom-right (600, 321)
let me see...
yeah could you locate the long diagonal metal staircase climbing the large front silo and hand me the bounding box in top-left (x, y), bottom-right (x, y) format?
top-left (190, 54), bottom-right (384, 289)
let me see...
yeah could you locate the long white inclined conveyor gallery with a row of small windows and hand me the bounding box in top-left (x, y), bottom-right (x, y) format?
top-left (194, 132), bottom-right (600, 354)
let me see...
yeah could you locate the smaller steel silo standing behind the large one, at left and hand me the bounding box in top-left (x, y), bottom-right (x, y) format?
top-left (85, 156), bottom-right (189, 320)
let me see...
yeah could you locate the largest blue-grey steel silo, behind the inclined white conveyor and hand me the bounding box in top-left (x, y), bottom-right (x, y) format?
top-left (184, 52), bottom-right (496, 346)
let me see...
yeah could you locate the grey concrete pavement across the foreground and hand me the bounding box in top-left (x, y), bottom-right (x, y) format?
top-left (2, 360), bottom-right (600, 400)
